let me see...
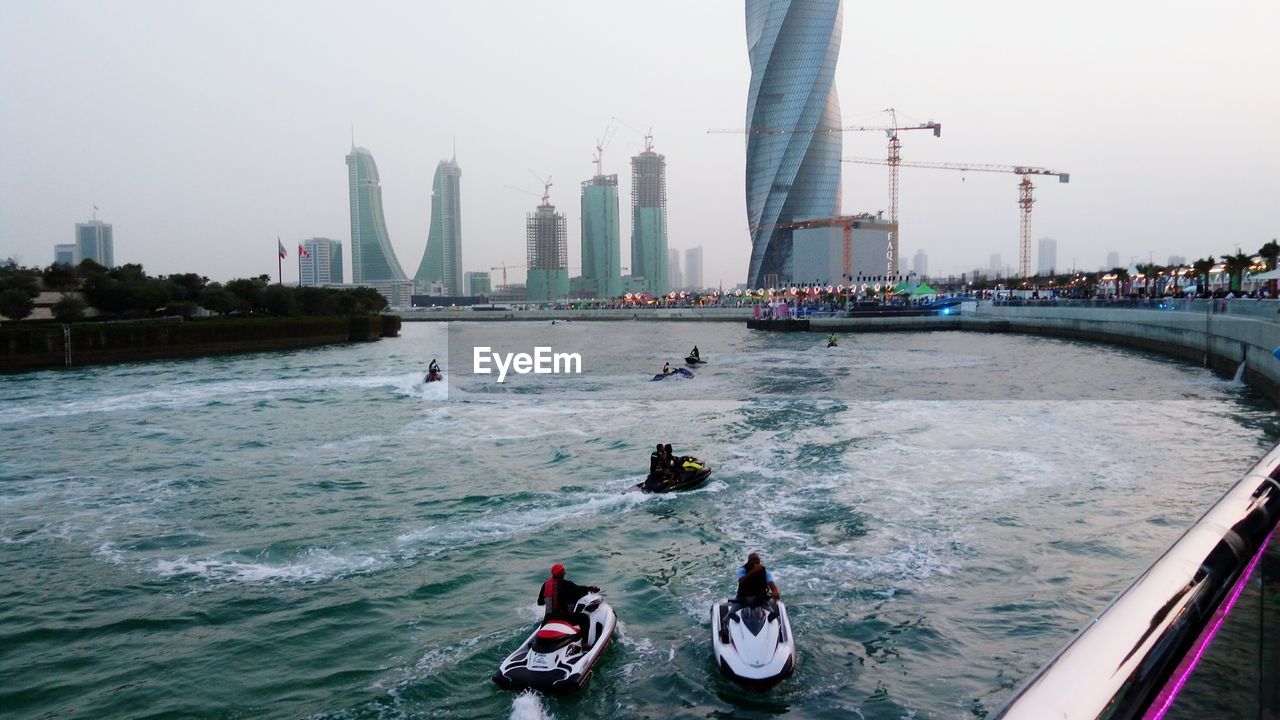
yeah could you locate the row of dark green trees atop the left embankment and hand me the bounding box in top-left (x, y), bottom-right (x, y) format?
top-left (0, 260), bottom-right (387, 322)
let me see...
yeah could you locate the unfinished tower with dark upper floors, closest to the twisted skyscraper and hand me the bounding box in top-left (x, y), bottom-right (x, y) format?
top-left (631, 138), bottom-right (668, 295)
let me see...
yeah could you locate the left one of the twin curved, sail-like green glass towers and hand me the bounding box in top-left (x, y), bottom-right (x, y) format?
top-left (347, 147), bottom-right (407, 284)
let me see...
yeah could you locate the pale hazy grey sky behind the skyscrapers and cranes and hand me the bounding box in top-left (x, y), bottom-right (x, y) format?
top-left (0, 0), bottom-right (1280, 287)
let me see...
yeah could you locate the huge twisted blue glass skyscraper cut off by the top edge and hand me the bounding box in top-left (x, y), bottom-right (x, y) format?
top-left (746, 0), bottom-right (842, 287)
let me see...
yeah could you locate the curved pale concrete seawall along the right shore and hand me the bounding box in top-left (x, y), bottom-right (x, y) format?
top-left (809, 301), bottom-right (1280, 405)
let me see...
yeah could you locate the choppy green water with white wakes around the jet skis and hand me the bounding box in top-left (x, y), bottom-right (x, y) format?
top-left (0, 323), bottom-right (1277, 719)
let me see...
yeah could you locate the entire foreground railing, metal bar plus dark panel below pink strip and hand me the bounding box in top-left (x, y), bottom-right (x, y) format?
top-left (997, 447), bottom-right (1280, 720)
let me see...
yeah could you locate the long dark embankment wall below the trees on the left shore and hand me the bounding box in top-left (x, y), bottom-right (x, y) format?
top-left (0, 315), bottom-right (401, 372)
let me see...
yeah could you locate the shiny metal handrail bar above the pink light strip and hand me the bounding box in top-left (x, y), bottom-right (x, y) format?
top-left (996, 446), bottom-right (1280, 720)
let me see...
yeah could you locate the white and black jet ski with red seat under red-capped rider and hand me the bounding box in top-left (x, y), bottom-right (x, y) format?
top-left (493, 592), bottom-right (618, 693)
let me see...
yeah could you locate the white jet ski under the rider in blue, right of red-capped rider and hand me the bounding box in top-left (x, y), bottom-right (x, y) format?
top-left (712, 598), bottom-right (796, 688)
